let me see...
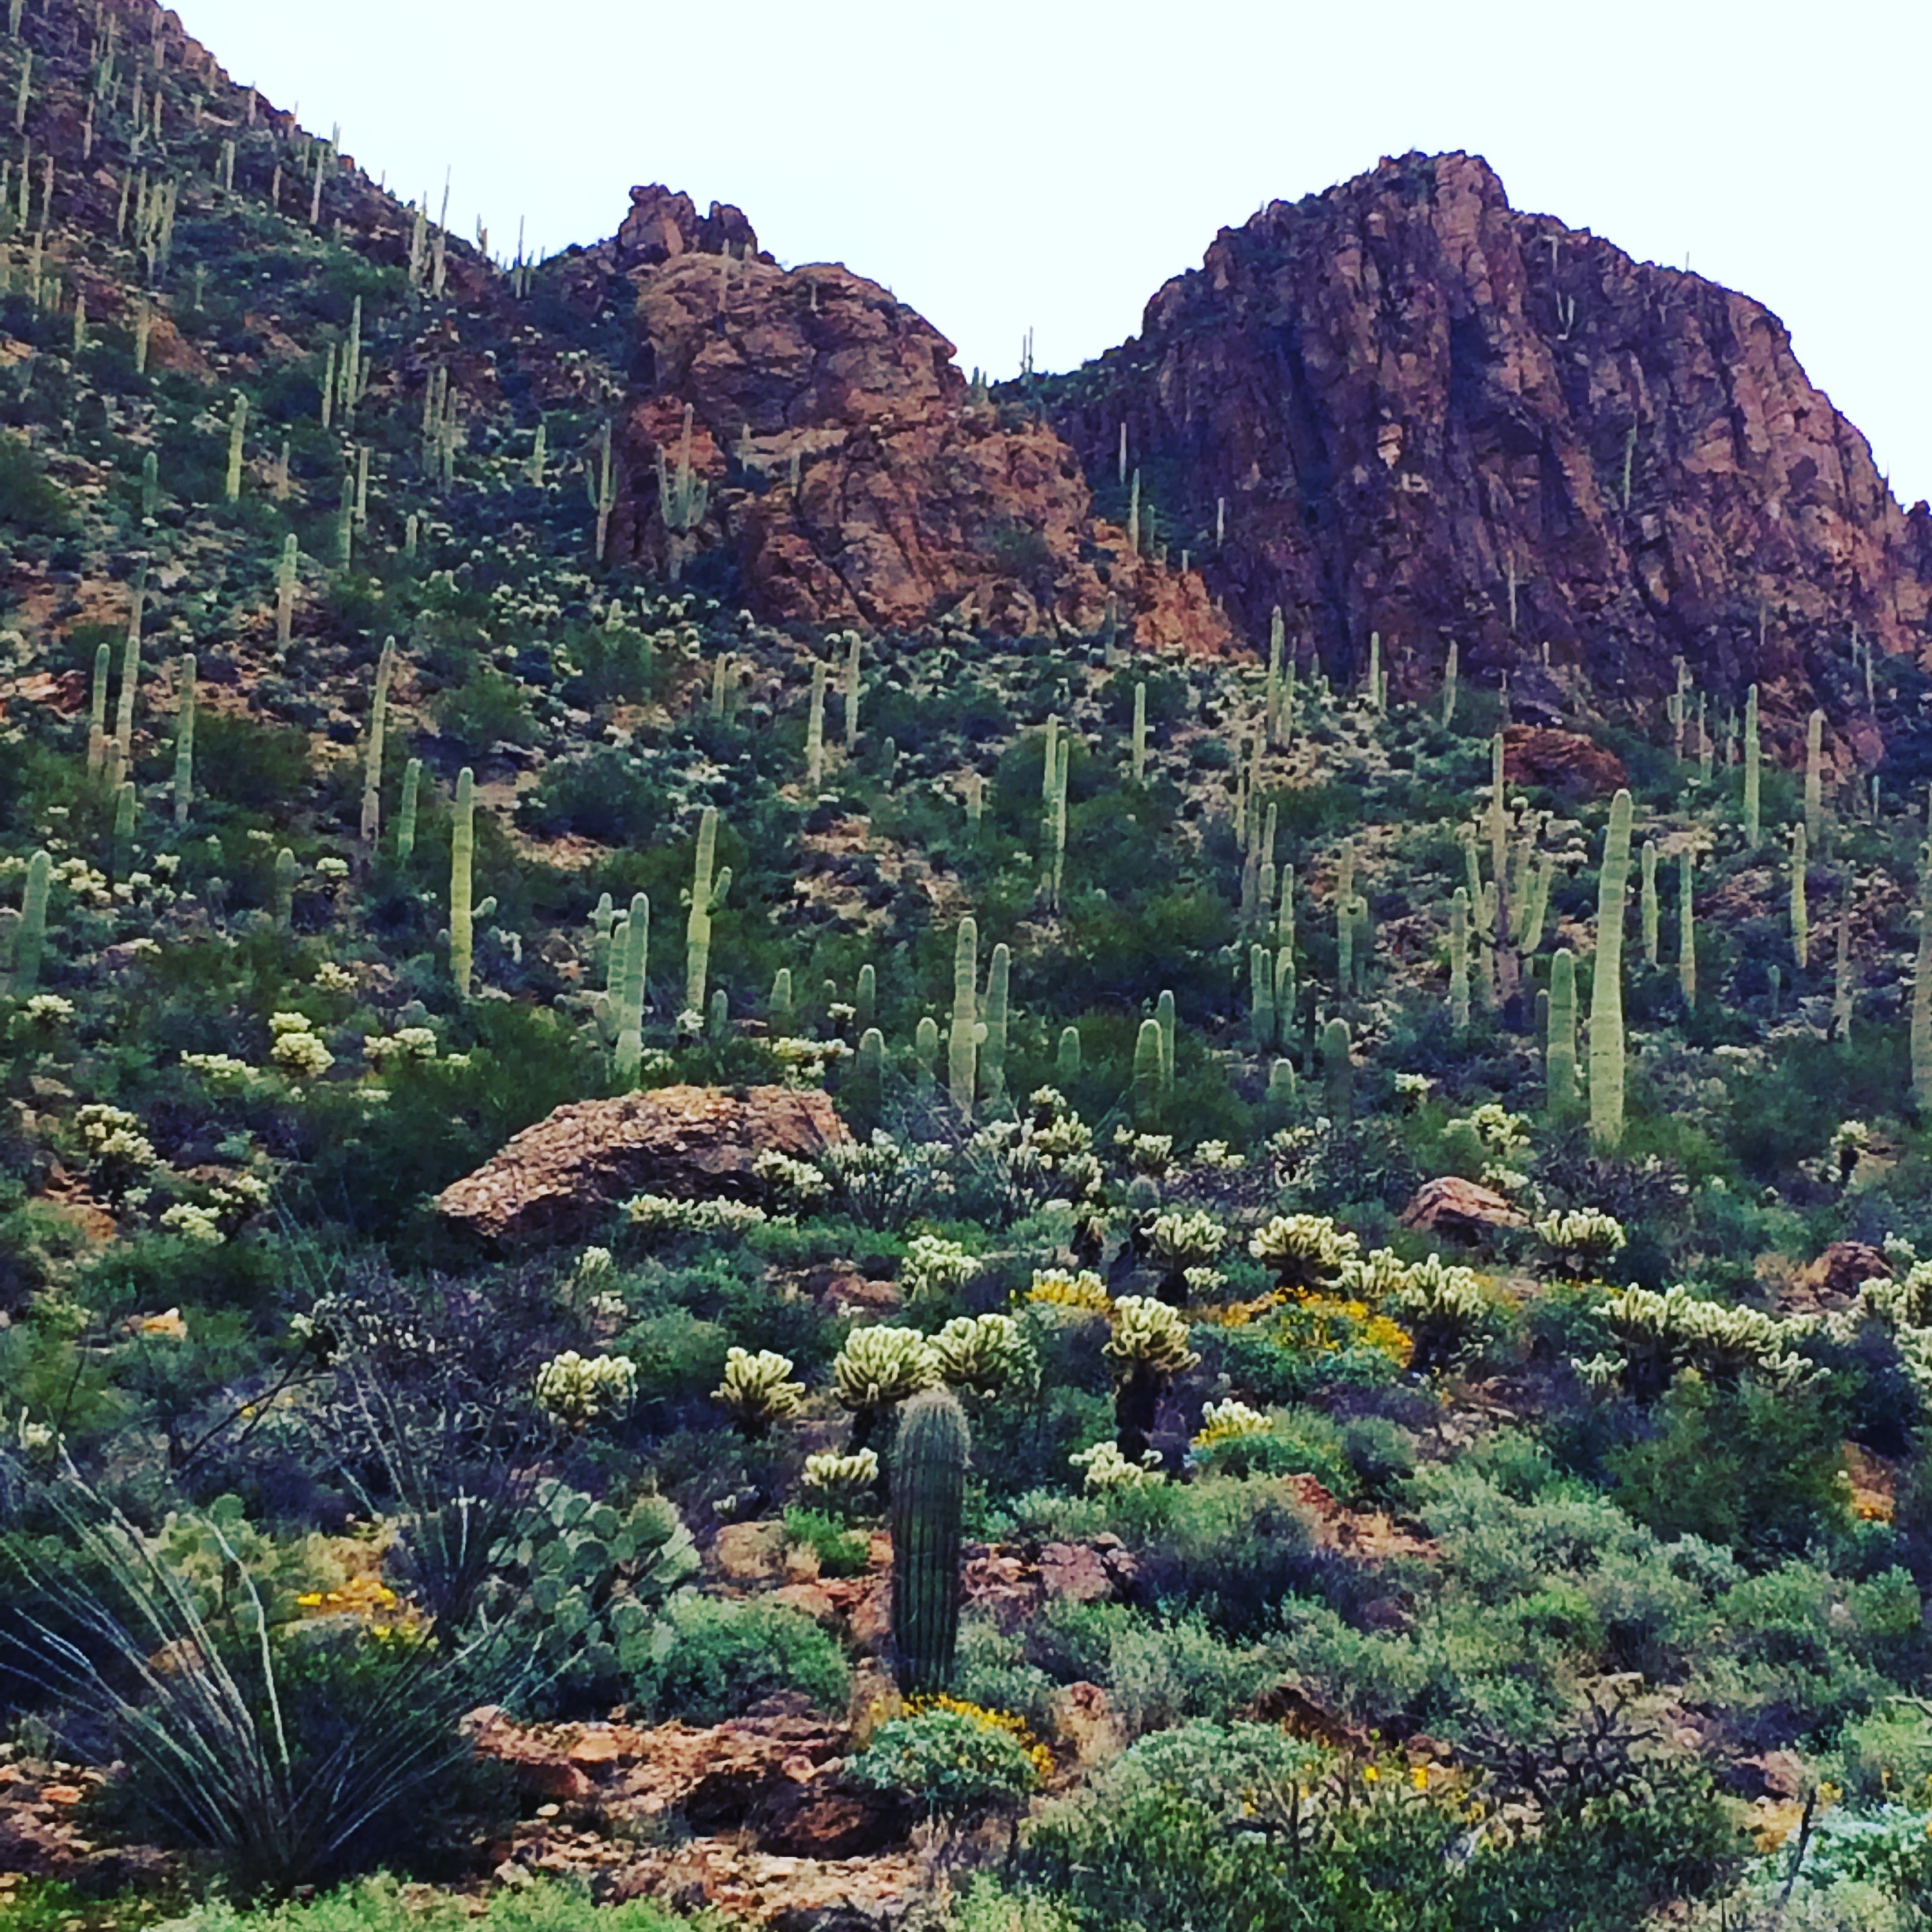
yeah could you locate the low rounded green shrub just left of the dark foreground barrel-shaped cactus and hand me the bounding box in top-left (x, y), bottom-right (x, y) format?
top-left (632, 1596), bottom-right (852, 1724)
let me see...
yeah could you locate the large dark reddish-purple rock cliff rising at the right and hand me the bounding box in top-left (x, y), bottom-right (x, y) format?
top-left (1055, 155), bottom-right (1932, 733)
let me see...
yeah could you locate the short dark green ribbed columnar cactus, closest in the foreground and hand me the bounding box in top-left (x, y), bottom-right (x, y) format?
top-left (893, 1389), bottom-right (972, 1693)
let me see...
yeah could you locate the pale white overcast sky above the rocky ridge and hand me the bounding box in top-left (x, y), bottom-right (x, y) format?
top-left (176, 0), bottom-right (1932, 502)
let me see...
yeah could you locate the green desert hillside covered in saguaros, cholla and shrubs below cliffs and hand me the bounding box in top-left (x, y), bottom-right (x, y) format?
top-left (0, 0), bottom-right (1932, 1932)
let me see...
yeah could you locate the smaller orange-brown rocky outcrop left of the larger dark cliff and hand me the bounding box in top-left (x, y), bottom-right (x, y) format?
top-left (580, 187), bottom-right (1227, 647)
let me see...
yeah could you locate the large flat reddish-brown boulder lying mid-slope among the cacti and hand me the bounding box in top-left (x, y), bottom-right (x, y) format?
top-left (437, 1086), bottom-right (846, 1240)
